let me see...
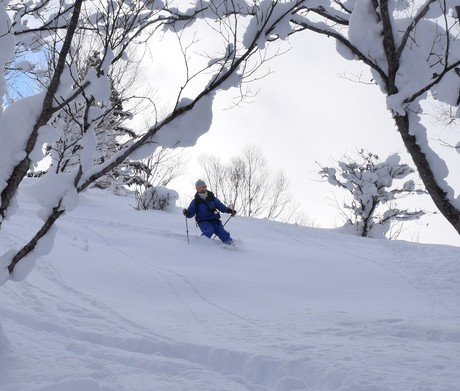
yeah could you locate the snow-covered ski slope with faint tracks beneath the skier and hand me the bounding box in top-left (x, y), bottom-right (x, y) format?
top-left (0, 190), bottom-right (460, 391)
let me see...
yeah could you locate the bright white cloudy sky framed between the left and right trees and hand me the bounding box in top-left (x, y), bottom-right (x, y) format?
top-left (165, 33), bottom-right (460, 246)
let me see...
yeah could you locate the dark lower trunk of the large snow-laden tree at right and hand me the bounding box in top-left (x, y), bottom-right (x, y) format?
top-left (394, 114), bottom-right (460, 234)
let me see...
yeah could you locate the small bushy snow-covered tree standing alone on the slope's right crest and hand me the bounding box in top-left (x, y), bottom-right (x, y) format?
top-left (319, 150), bottom-right (425, 237)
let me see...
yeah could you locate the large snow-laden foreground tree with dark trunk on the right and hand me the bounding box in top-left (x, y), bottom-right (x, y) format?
top-left (282, 0), bottom-right (460, 234)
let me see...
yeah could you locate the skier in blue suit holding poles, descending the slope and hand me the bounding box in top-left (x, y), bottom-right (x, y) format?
top-left (183, 179), bottom-right (236, 245)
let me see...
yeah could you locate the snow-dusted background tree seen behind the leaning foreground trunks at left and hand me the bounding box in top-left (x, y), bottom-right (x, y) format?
top-left (46, 47), bottom-right (141, 194)
